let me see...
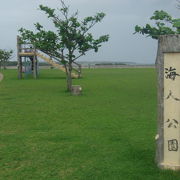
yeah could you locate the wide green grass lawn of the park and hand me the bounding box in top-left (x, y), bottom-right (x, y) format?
top-left (0, 69), bottom-right (180, 180)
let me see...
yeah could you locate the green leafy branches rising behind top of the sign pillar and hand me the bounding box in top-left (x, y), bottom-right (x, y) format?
top-left (135, 10), bottom-right (180, 39)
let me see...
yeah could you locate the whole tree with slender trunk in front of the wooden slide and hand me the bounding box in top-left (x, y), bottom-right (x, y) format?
top-left (19, 0), bottom-right (109, 91)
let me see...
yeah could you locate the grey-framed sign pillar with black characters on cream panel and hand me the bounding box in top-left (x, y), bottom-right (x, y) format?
top-left (156, 35), bottom-right (180, 170)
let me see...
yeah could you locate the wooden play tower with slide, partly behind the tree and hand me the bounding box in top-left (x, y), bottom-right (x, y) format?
top-left (17, 36), bottom-right (81, 79)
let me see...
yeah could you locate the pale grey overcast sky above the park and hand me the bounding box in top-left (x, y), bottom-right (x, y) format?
top-left (0, 0), bottom-right (180, 63)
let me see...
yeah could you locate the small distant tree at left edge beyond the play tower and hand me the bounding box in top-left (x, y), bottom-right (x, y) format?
top-left (0, 49), bottom-right (13, 69)
